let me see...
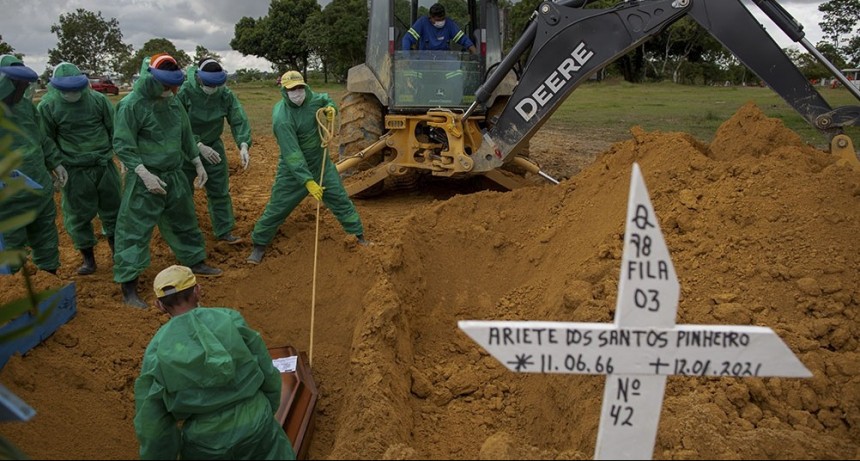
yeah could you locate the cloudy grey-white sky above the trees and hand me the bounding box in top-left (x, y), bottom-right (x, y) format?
top-left (0, 0), bottom-right (823, 74)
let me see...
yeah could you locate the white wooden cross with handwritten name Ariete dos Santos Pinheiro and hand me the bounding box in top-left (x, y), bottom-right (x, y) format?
top-left (458, 163), bottom-right (812, 459)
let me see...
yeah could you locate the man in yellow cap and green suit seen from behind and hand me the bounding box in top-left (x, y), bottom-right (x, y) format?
top-left (134, 266), bottom-right (296, 459)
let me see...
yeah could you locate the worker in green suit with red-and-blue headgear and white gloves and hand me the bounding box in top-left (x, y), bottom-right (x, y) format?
top-left (113, 53), bottom-right (221, 308)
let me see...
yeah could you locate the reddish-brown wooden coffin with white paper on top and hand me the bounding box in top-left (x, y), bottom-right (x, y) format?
top-left (269, 346), bottom-right (319, 459)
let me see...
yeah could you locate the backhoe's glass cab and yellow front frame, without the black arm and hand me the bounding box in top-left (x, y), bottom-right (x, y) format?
top-left (337, 0), bottom-right (530, 197)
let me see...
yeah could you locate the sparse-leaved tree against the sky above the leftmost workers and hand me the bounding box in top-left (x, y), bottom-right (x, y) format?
top-left (48, 8), bottom-right (132, 74)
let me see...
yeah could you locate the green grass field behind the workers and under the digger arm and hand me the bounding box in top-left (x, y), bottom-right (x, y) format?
top-left (110, 81), bottom-right (860, 149)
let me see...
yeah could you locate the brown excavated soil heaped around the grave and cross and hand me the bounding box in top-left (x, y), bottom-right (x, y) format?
top-left (0, 105), bottom-right (860, 459)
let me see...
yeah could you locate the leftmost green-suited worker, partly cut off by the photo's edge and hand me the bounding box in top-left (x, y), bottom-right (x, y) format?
top-left (0, 54), bottom-right (68, 274)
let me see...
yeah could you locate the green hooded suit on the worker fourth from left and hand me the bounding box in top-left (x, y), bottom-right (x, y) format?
top-left (176, 66), bottom-right (251, 238)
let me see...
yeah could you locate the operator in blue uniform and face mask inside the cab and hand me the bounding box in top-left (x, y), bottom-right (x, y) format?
top-left (402, 3), bottom-right (477, 54)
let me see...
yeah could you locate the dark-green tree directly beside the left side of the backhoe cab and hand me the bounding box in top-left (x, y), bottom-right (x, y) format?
top-left (301, 0), bottom-right (367, 82)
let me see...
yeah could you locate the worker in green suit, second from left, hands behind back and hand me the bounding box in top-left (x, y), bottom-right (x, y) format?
top-left (38, 62), bottom-right (121, 275)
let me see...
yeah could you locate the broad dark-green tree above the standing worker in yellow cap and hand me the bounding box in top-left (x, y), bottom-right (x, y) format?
top-left (230, 0), bottom-right (320, 76)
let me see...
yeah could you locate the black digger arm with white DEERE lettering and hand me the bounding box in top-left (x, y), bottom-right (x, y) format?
top-left (470, 0), bottom-right (860, 172)
